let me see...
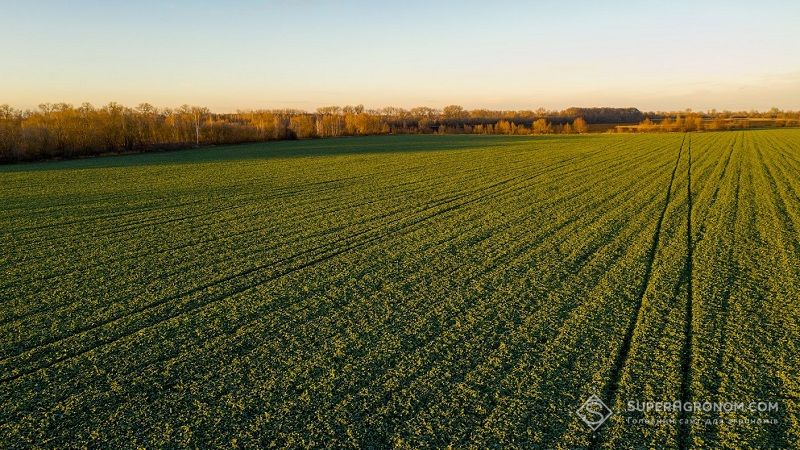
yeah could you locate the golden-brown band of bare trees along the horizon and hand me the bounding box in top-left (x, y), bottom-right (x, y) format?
top-left (0, 103), bottom-right (800, 162)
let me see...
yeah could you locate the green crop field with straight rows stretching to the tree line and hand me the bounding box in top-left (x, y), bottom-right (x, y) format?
top-left (0, 130), bottom-right (800, 449)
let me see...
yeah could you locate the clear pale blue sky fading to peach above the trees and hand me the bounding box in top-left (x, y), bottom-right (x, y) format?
top-left (0, 0), bottom-right (800, 112)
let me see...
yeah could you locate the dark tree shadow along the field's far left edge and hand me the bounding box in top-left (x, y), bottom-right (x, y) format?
top-left (0, 135), bottom-right (589, 172)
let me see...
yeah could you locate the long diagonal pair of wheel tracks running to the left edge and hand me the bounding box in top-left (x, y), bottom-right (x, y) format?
top-left (0, 150), bottom-right (583, 383)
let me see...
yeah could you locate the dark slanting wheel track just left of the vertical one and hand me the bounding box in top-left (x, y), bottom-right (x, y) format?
top-left (589, 133), bottom-right (686, 449)
